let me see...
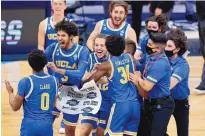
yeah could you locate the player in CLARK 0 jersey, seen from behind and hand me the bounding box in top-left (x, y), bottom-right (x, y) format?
top-left (5, 50), bottom-right (58, 136)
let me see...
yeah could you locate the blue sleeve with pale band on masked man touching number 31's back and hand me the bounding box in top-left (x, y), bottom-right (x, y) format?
top-left (145, 60), bottom-right (171, 84)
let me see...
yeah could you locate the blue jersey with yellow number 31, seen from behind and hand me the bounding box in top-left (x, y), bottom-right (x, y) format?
top-left (108, 53), bottom-right (137, 102)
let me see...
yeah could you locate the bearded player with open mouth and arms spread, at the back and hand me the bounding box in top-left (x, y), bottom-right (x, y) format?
top-left (87, 1), bottom-right (137, 51)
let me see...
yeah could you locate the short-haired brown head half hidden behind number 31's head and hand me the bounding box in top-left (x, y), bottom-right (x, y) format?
top-left (125, 39), bottom-right (136, 56)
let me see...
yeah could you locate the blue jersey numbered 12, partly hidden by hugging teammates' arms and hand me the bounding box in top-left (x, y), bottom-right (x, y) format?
top-left (88, 53), bottom-right (111, 111)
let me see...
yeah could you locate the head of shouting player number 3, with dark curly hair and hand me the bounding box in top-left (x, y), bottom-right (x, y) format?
top-left (55, 20), bottom-right (78, 49)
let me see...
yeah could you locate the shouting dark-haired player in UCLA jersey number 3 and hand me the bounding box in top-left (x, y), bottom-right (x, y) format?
top-left (45, 21), bottom-right (89, 136)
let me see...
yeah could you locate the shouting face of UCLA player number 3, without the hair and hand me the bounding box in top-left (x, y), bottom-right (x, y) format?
top-left (57, 30), bottom-right (72, 49)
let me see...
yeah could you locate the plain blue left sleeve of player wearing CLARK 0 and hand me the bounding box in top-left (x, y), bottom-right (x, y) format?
top-left (17, 78), bottom-right (31, 97)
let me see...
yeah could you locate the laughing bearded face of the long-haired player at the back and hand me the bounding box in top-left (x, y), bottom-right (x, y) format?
top-left (110, 6), bottom-right (126, 27)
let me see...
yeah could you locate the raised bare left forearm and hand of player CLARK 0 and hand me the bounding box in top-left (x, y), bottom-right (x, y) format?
top-left (5, 81), bottom-right (24, 111)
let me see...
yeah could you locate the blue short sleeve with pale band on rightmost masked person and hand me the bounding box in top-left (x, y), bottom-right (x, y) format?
top-left (171, 64), bottom-right (189, 82)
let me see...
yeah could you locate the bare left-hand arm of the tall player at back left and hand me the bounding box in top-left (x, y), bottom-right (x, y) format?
top-left (38, 20), bottom-right (46, 50)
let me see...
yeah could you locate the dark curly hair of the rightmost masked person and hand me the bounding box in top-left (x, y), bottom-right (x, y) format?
top-left (167, 28), bottom-right (188, 56)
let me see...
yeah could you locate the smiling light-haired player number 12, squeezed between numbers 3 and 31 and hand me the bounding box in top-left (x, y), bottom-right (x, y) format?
top-left (76, 34), bottom-right (111, 136)
